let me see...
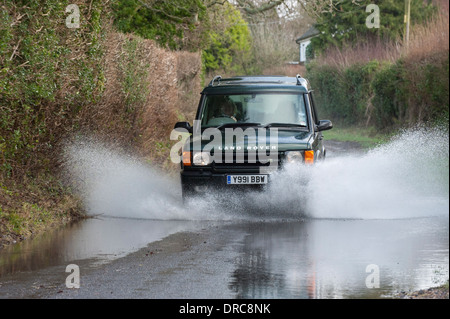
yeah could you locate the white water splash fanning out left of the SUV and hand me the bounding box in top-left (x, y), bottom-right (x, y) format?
top-left (65, 138), bottom-right (184, 220)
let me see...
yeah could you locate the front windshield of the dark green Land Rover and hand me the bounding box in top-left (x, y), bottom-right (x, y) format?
top-left (201, 93), bottom-right (307, 127)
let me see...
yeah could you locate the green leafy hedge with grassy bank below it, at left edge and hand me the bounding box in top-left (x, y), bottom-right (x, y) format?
top-left (0, 1), bottom-right (104, 243)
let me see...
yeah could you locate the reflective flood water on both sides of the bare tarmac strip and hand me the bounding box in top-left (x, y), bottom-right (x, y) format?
top-left (0, 217), bottom-right (449, 299)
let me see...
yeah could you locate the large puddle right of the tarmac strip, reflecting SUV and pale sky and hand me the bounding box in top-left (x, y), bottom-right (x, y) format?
top-left (229, 217), bottom-right (449, 298)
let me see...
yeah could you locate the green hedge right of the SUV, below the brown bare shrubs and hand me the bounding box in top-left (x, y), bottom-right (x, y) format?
top-left (307, 53), bottom-right (449, 129)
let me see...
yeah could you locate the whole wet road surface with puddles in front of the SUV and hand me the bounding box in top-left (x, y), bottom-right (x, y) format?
top-left (0, 140), bottom-right (449, 299)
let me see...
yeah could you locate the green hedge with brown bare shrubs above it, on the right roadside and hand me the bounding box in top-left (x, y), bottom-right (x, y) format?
top-left (307, 1), bottom-right (449, 133)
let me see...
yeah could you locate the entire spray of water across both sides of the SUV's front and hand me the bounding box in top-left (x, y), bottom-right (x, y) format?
top-left (66, 129), bottom-right (449, 220)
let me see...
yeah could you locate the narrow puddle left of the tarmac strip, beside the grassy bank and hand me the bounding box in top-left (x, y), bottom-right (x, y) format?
top-left (0, 217), bottom-right (201, 277)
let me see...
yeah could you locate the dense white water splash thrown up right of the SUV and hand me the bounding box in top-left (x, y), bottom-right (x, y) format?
top-left (308, 128), bottom-right (449, 219)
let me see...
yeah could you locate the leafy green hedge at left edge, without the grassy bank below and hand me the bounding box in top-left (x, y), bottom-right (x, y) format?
top-left (0, 0), bottom-right (104, 178)
